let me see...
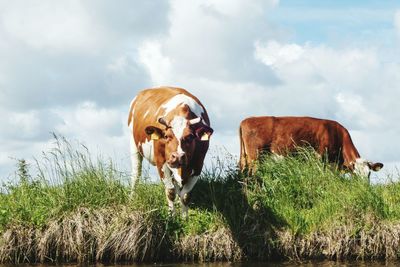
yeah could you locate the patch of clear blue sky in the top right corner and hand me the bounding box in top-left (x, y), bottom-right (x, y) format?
top-left (268, 0), bottom-right (400, 46)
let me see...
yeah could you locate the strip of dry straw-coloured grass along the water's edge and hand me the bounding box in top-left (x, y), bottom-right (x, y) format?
top-left (0, 207), bottom-right (400, 264)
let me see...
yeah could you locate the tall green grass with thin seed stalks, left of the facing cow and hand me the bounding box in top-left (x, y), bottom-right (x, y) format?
top-left (0, 136), bottom-right (130, 231)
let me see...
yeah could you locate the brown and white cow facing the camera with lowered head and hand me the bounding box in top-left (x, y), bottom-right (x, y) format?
top-left (128, 87), bottom-right (213, 217)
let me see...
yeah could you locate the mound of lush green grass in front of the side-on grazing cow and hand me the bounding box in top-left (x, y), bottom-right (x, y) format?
top-left (247, 149), bottom-right (400, 237)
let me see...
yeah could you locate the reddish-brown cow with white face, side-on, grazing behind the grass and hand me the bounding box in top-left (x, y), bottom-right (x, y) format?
top-left (239, 116), bottom-right (383, 176)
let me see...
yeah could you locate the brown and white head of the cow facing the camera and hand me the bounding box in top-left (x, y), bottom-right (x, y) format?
top-left (145, 116), bottom-right (213, 168)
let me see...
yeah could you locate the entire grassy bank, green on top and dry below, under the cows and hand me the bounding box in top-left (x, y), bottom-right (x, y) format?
top-left (0, 139), bottom-right (400, 263)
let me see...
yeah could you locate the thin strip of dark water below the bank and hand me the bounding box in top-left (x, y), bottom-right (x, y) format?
top-left (0, 261), bottom-right (394, 267)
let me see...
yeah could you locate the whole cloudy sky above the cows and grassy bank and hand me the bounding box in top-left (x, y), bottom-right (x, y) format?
top-left (0, 0), bottom-right (400, 184)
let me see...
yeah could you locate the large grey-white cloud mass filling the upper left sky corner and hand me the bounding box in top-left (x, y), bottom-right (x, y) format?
top-left (0, 0), bottom-right (168, 110)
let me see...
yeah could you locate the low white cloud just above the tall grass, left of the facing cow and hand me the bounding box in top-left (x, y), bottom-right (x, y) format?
top-left (0, 101), bottom-right (129, 180)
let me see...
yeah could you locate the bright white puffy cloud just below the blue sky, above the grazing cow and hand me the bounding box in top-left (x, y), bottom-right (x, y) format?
top-left (255, 41), bottom-right (380, 90)
